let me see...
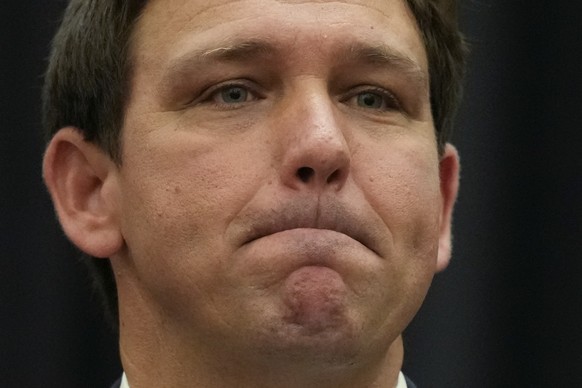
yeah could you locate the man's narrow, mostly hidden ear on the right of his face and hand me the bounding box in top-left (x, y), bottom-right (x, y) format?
top-left (436, 144), bottom-right (460, 272)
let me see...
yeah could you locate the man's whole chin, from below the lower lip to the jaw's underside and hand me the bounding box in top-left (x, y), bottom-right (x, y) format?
top-left (240, 266), bottom-right (389, 367)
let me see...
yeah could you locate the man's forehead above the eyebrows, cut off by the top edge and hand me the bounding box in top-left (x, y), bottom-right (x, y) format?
top-left (133, 0), bottom-right (427, 70)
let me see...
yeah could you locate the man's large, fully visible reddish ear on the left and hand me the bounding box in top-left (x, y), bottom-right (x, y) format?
top-left (43, 127), bottom-right (123, 258)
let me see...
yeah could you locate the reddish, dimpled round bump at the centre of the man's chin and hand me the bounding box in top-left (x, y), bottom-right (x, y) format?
top-left (281, 266), bottom-right (348, 336)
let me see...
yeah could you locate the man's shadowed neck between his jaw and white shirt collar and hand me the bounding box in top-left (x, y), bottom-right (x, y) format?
top-left (120, 324), bottom-right (403, 388)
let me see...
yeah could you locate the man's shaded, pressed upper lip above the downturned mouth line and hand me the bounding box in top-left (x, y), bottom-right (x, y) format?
top-left (245, 203), bottom-right (380, 254)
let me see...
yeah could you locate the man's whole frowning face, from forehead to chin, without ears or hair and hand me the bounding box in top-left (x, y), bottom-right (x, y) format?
top-left (112, 0), bottom-right (456, 364)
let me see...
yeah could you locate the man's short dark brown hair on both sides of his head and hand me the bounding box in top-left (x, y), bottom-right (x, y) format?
top-left (43, 0), bottom-right (465, 326)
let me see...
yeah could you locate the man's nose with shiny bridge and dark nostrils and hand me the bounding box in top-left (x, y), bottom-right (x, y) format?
top-left (275, 90), bottom-right (351, 191)
